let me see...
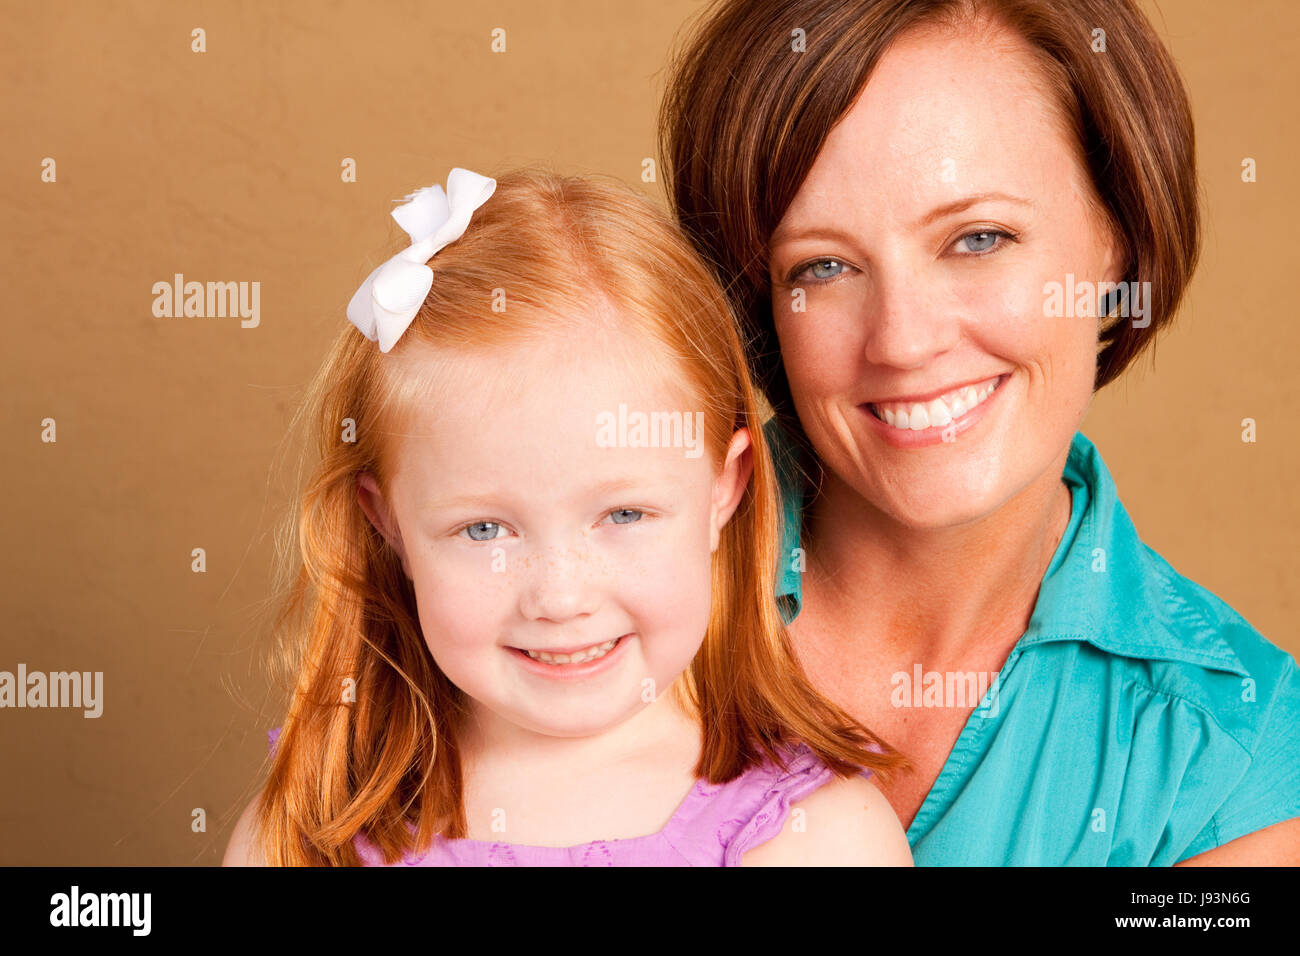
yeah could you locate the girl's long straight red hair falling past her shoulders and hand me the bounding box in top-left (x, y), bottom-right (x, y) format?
top-left (254, 169), bottom-right (905, 865)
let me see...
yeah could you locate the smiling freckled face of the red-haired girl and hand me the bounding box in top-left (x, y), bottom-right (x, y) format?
top-left (359, 314), bottom-right (750, 736)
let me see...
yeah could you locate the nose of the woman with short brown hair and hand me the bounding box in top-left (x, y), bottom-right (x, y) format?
top-left (863, 265), bottom-right (961, 368)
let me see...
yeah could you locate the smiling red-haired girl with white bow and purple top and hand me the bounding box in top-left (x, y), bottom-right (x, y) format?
top-left (226, 169), bottom-right (911, 866)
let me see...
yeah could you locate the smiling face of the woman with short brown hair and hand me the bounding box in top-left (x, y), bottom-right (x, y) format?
top-left (770, 20), bottom-right (1121, 528)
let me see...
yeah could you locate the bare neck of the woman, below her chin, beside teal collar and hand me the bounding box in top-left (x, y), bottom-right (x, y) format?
top-left (803, 449), bottom-right (1070, 665)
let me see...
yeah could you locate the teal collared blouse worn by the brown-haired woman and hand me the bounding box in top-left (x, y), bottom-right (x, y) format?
top-left (764, 419), bottom-right (1300, 866)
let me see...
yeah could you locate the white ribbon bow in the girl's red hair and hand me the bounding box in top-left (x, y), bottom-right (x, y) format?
top-left (347, 166), bottom-right (497, 352)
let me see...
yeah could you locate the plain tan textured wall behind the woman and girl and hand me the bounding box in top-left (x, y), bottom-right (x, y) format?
top-left (0, 0), bottom-right (1300, 865)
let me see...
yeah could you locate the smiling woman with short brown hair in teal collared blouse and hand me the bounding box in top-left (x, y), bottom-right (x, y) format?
top-left (662, 0), bottom-right (1300, 865)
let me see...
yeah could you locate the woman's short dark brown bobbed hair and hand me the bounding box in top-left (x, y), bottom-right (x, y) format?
top-left (659, 0), bottom-right (1200, 437)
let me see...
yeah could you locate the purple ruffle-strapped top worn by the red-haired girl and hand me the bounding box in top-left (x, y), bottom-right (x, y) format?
top-left (268, 727), bottom-right (847, 866)
